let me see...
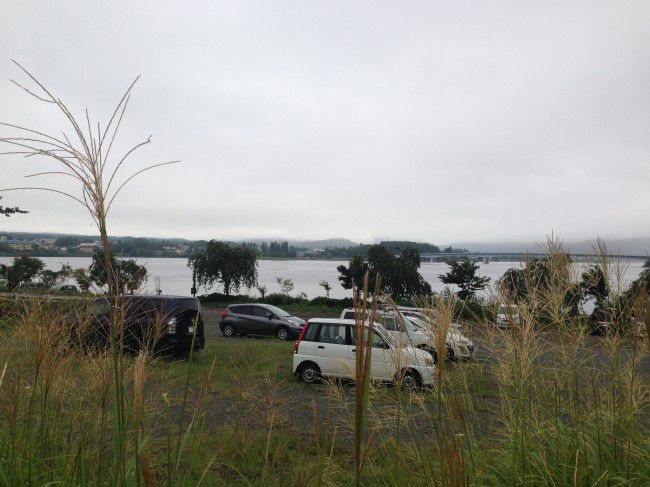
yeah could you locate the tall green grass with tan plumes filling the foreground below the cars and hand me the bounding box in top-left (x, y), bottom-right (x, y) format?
top-left (0, 303), bottom-right (650, 486)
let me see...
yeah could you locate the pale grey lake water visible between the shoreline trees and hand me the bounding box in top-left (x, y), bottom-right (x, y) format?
top-left (0, 257), bottom-right (643, 298)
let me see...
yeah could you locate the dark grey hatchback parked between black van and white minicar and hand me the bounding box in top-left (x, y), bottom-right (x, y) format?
top-left (219, 304), bottom-right (305, 340)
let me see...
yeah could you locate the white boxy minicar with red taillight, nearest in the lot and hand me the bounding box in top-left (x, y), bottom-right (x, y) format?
top-left (293, 318), bottom-right (435, 388)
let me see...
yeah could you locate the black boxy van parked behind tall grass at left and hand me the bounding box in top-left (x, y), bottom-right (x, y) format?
top-left (85, 295), bottom-right (205, 354)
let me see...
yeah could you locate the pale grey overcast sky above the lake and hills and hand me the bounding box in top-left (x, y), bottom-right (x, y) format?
top-left (0, 0), bottom-right (650, 243)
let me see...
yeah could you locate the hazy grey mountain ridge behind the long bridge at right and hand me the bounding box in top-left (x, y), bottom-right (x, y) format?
top-left (453, 237), bottom-right (650, 256)
